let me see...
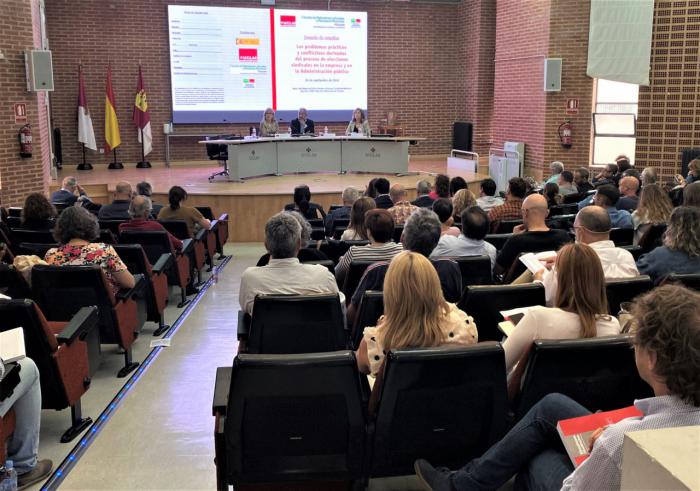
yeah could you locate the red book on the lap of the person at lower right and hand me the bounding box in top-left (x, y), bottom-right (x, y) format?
top-left (557, 406), bottom-right (643, 467)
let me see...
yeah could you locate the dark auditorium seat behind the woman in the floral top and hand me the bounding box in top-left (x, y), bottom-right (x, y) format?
top-left (32, 265), bottom-right (145, 377)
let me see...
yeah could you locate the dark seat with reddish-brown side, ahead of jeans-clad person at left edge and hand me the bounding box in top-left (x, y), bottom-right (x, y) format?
top-left (0, 300), bottom-right (98, 446)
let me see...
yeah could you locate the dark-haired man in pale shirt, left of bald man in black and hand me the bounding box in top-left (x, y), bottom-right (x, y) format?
top-left (430, 206), bottom-right (497, 269)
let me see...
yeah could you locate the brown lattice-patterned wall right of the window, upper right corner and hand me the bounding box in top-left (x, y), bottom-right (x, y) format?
top-left (636, 1), bottom-right (700, 181)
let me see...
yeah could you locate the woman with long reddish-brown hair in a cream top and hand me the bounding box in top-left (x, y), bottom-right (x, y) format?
top-left (503, 243), bottom-right (620, 371)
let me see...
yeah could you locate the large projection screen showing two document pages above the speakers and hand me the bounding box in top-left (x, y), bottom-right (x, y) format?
top-left (168, 5), bottom-right (367, 124)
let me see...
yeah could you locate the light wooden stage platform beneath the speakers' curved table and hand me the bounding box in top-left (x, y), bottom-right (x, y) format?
top-left (57, 159), bottom-right (488, 242)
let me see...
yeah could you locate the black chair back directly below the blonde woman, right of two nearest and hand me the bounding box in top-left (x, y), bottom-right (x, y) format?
top-left (370, 343), bottom-right (508, 477)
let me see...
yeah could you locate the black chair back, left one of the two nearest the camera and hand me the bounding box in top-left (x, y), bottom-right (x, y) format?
top-left (224, 351), bottom-right (366, 489)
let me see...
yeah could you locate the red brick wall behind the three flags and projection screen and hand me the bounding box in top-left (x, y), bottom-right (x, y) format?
top-left (47, 0), bottom-right (468, 164)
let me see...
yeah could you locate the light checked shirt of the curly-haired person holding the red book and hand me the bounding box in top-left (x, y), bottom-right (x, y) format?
top-left (562, 396), bottom-right (700, 491)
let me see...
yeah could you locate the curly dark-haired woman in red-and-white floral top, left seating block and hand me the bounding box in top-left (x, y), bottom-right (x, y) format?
top-left (44, 207), bottom-right (136, 293)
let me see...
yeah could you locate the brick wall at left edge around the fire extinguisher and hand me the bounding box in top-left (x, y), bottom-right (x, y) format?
top-left (0, 0), bottom-right (51, 206)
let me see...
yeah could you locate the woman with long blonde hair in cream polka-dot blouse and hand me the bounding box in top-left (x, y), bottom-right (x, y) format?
top-left (357, 251), bottom-right (478, 376)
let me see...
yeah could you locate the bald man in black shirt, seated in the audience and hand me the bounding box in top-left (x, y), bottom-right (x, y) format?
top-left (494, 194), bottom-right (571, 275)
